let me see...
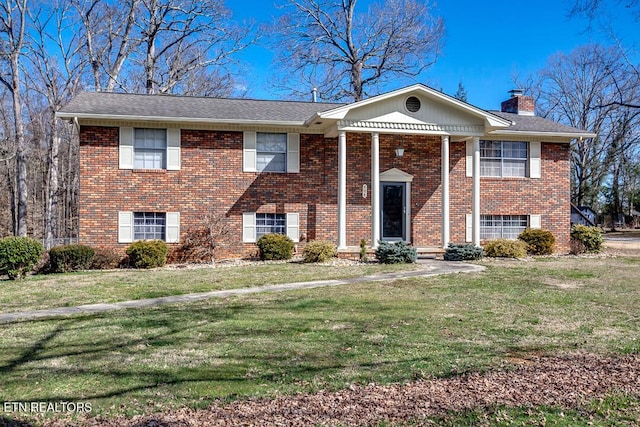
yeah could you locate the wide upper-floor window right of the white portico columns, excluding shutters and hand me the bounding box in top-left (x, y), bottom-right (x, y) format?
top-left (480, 141), bottom-right (528, 177)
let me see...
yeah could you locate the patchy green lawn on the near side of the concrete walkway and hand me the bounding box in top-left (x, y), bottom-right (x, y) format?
top-left (0, 258), bottom-right (640, 425)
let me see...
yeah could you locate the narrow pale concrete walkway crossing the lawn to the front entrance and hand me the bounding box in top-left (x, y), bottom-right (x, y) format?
top-left (0, 259), bottom-right (485, 323)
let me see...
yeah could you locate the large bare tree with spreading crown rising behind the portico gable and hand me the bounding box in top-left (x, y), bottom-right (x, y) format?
top-left (272, 0), bottom-right (444, 101)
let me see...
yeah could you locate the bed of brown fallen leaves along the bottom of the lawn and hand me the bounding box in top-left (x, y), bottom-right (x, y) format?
top-left (15, 354), bottom-right (640, 427)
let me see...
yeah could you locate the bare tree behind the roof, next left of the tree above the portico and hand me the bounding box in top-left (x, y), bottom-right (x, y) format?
top-left (136, 0), bottom-right (252, 94)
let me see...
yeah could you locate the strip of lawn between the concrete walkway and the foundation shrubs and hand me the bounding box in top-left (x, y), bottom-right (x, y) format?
top-left (0, 263), bottom-right (415, 313)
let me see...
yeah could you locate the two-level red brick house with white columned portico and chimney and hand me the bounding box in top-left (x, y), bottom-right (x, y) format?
top-left (58, 84), bottom-right (594, 256)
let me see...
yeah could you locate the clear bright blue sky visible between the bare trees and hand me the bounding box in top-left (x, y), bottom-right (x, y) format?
top-left (226, 0), bottom-right (640, 109)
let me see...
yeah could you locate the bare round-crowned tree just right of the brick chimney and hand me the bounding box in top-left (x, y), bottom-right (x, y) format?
top-left (535, 45), bottom-right (636, 209)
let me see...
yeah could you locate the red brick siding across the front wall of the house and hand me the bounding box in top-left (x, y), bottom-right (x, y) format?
top-left (80, 126), bottom-right (570, 256)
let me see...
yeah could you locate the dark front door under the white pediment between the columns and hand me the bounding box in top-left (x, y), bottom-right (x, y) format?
top-left (380, 182), bottom-right (407, 241)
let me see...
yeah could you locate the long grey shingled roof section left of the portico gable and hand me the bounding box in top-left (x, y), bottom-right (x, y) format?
top-left (58, 92), bottom-right (344, 124)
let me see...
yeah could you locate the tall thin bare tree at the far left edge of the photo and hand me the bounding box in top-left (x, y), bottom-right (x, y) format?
top-left (0, 0), bottom-right (28, 236)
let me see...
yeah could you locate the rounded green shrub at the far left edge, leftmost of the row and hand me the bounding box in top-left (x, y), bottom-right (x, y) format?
top-left (0, 237), bottom-right (44, 280)
